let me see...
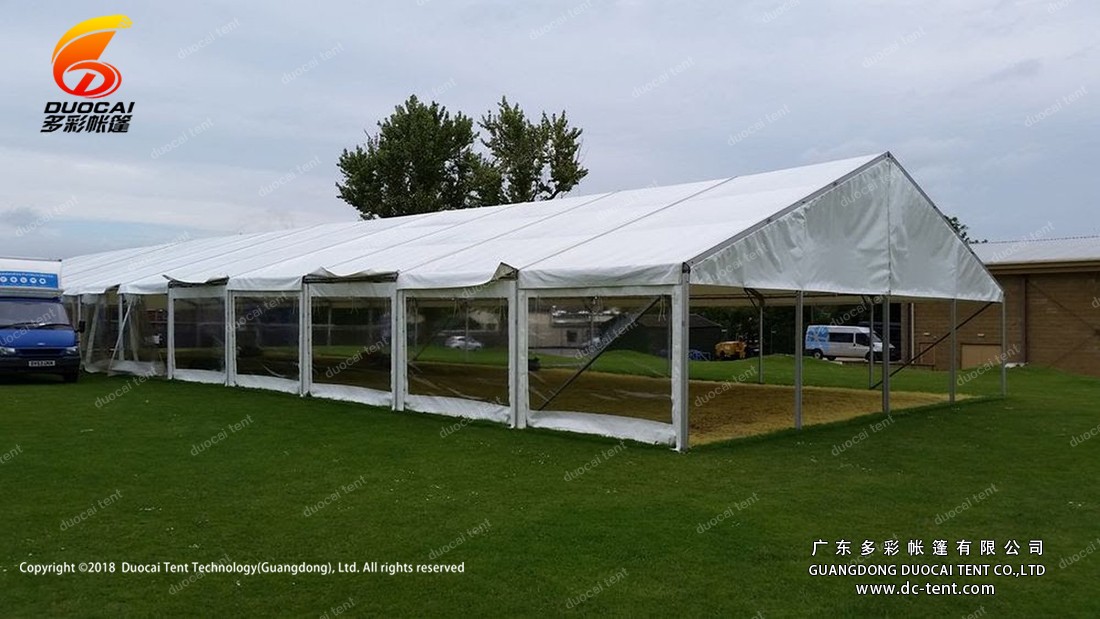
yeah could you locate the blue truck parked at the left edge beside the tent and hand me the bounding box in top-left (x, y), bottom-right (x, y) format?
top-left (0, 258), bottom-right (80, 383)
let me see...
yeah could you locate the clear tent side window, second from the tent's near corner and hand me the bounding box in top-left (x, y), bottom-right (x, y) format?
top-left (406, 298), bottom-right (510, 406)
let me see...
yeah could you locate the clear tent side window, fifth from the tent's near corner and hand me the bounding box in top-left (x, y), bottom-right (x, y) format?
top-left (173, 297), bottom-right (226, 372)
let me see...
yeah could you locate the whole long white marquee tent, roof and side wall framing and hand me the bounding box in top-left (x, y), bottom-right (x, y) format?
top-left (64, 153), bottom-right (1002, 449)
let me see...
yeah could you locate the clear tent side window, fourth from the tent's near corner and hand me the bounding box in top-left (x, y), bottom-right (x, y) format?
top-left (233, 294), bottom-right (300, 380)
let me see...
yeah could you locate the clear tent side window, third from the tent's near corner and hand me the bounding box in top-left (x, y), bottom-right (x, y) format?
top-left (311, 297), bottom-right (393, 391)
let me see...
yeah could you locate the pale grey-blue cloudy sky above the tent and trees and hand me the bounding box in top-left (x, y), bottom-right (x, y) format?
top-left (0, 0), bottom-right (1100, 257)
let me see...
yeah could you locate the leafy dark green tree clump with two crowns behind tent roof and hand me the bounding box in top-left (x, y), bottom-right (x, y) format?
top-left (337, 96), bottom-right (589, 219)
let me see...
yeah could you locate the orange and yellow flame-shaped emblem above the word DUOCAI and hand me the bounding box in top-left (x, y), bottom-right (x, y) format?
top-left (53, 15), bottom-right (133, 99)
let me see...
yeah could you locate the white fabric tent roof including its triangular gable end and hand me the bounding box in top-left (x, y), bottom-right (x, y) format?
top-left (64, 153), bottom-right (1002, 301)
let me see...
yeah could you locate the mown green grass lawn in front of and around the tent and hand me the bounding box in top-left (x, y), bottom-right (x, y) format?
top-left (0, 365), bottom-right (1100, 618)
